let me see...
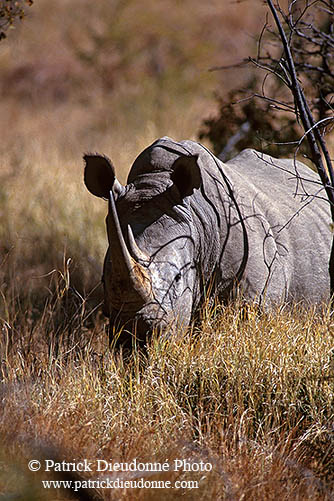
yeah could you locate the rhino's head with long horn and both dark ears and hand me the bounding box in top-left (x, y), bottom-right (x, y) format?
top-left (84, 147), bottom-right (201, 343)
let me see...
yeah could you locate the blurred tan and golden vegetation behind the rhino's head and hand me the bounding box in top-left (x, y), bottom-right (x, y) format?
top-left (0, 0), bottom-right (265, 300)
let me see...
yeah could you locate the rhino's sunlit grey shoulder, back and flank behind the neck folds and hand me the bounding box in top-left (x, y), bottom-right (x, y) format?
top-left (176, 141), bottom-right (331, 303)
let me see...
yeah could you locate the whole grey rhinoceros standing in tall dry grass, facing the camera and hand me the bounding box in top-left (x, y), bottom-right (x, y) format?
top-left (84, 137), bottom-right (331, 339)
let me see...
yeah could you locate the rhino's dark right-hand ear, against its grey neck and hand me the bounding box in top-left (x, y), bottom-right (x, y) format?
top-left (171, 155), bottom-right (202, 198)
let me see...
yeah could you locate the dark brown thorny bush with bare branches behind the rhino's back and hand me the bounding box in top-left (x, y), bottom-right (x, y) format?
top-left (199, 0), bottom-right (334, 162)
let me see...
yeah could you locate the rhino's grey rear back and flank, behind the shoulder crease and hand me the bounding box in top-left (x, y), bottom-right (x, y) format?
top-left (227, 150), bottom-right (331, 302)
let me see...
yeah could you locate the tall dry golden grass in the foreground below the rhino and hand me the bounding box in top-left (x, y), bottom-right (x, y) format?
top-left (0, 276), bottom-right (334, 500)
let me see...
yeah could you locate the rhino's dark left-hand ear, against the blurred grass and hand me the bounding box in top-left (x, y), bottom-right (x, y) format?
top-left (84, 154), bottom-right (124, 199)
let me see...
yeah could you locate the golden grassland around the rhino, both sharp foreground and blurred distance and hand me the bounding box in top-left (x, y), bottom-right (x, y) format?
top-left (0, 0), bottom-right (334, 501)
